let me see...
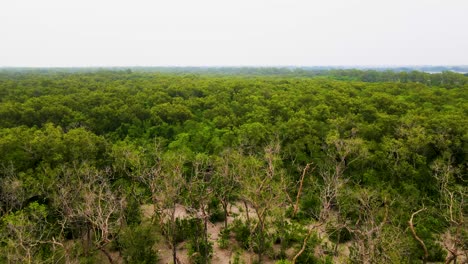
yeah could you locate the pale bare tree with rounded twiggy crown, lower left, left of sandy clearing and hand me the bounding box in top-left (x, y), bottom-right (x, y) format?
top-left (55, 165), bottom-right (126, 263)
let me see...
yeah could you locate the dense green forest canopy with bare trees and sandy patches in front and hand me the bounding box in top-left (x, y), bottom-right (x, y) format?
top-left (0, 69), bottom-right (468, 263)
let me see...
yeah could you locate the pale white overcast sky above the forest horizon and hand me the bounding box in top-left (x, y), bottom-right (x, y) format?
top-left (0, 0), bottom-right (468, 67)
